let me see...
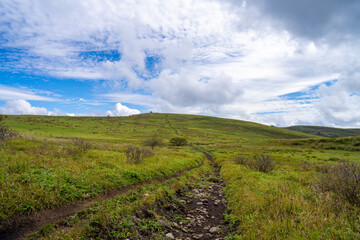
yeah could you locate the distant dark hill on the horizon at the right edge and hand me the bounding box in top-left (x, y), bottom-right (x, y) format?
top-left (286, 125), bottom-right (360, 138)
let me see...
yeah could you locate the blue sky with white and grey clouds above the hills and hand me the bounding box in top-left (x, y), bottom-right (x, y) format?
top-left (0, 0), bottom-right (360, 127)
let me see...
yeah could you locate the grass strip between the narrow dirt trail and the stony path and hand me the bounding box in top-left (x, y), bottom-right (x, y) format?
top-left (33, 158), bottom-right (211, 239)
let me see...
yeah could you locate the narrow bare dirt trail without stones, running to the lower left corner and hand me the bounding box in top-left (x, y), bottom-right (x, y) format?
top-left (0, 159), bottom-right (202, 240)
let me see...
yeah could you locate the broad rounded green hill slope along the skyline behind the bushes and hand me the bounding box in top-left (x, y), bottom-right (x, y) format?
top-left (7, 113), bottom-right (315, 141)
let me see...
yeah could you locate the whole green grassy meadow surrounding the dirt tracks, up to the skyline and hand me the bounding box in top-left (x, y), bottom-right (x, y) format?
top-left (0, 113), bottom-right (360, 239)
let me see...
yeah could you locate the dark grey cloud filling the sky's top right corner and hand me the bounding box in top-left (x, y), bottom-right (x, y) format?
top-left (229, 0), bottom-right (360, 41)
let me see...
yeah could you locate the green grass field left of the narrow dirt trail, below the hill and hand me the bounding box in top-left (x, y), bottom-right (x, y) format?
top-left (0, 133), bottom-right (203, 222)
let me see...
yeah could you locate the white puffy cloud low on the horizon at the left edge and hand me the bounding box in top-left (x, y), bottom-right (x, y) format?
top-left (0, 100), bottom-right (51, 115)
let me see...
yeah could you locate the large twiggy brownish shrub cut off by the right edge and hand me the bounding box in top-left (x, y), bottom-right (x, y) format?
top-left (315, 162), bottom-right (360, 205)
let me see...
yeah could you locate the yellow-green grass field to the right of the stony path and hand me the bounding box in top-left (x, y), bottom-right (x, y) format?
top-left (207, 140), bottom-right (360, 239)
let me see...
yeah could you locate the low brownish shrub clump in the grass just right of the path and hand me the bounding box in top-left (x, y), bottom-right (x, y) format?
top-left (234, 155), bottom-right (275, 173)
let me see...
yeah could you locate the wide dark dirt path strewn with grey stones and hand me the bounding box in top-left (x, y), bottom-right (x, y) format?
top-left (159, 168), bottom-right (230, 240)
